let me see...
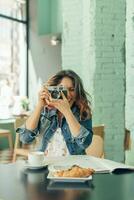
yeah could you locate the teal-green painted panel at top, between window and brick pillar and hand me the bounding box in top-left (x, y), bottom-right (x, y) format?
top-left (37, 0), bottom-right (62, 35)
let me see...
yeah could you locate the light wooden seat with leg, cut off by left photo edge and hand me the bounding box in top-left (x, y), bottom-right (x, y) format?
top-left (0, 129), bottom-right (13, 151)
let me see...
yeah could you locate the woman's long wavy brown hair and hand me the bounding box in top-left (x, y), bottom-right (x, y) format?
top-left (48, 70), bottom-right (91, 119)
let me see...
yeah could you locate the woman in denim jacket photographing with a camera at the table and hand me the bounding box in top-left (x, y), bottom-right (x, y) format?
top-left (17, 70), bottom-right (92, 156)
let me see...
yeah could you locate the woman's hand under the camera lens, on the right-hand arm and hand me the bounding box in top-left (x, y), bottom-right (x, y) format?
top-left (49, 92), bottom-right (70, 116)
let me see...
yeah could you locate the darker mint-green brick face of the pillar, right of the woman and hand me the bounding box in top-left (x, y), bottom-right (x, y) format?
top-left (94, 0), bottom-right (125, 161)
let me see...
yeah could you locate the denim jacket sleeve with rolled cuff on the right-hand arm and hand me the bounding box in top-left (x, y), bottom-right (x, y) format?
top-left (72, 119), bottom-right (93, 150)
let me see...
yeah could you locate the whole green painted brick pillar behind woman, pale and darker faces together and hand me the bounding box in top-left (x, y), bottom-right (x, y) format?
top-left (62, 0), bottom-right (125, 161)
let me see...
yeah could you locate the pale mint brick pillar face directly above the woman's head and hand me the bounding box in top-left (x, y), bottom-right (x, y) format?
top-left (62, 0), bottom-right (83, 73)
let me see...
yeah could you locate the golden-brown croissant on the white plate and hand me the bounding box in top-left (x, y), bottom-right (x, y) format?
top-left (54, 165), bottom-right (95, 177)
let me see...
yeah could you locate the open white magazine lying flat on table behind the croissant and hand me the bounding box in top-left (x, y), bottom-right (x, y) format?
top-left (46, 155), bottom-right (134, 173)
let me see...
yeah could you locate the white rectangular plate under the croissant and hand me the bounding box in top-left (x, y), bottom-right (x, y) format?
top-left (47, 172), bottom-right (92, 182)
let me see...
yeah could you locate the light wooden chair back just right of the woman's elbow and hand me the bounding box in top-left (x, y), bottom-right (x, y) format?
top-left (86, 125), bottom-right (104, 158)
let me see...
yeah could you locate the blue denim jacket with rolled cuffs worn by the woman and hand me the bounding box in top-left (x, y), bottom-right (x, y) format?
top-left (16, 106), bottom-right (93, 155)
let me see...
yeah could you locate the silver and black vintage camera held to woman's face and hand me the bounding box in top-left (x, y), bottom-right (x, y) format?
top-left (47, 86), bottom-right (67, 99)
